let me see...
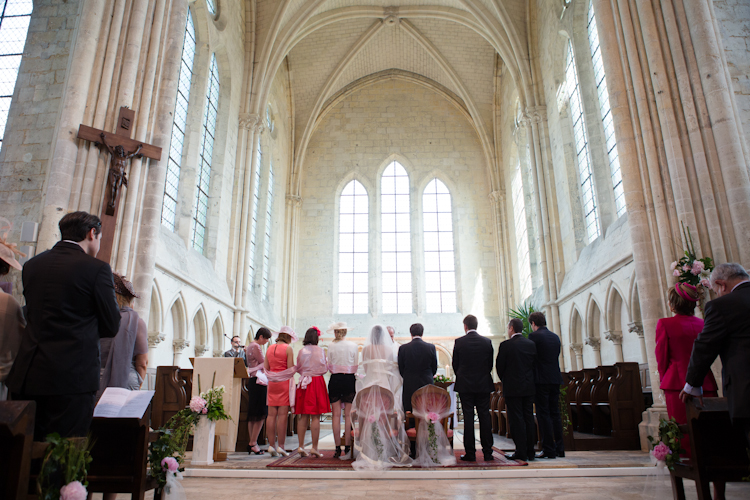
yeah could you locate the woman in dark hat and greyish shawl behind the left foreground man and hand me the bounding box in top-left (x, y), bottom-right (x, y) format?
top-left (98, 273), bottom-right (148, 396)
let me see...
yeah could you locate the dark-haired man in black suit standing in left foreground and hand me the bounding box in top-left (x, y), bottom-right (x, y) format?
top-left (8, 212), bottom-right (120, 441)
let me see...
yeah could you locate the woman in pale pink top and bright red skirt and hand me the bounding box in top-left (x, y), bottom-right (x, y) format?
top-left (294, 326), bottom-right (331, 457)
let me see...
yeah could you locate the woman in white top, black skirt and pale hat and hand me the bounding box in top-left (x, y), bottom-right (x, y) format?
top-left (327, 323), bottom-right (359, 460)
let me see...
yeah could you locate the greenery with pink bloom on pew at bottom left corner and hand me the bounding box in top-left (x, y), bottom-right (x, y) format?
top-left (37, 432), bottom-right (91, 500)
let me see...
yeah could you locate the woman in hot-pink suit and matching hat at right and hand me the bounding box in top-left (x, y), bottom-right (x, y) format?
top-left (656, 283), bottom-right (718, 456)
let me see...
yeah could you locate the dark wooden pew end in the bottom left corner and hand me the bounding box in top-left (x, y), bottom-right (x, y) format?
top-left (0, 401), bottom-right (36, 500)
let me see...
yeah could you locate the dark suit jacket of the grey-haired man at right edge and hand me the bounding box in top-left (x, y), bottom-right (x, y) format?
top-left (685, 283), bottom-right (750, 418)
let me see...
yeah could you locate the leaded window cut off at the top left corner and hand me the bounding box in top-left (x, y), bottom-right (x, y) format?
top-left (0, 0), bottom-right (34, 148)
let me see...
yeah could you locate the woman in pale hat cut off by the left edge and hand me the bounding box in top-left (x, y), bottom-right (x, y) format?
top-left (0, 218), bottom-right (26, 401)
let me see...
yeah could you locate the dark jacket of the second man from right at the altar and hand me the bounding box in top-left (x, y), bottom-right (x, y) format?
top-left (495, 335), bottom-right (536, 398)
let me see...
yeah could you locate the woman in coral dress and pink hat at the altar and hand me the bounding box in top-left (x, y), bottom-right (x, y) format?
top-left (264, 326), bottom-right (297, 457)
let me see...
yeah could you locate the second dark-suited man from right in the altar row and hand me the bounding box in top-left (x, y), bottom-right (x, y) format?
top-left (495, 318), bottom-right (536, 461)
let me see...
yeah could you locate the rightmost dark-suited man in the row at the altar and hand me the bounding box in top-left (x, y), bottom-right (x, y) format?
top-left (529, 312), bottom-right (565, 458)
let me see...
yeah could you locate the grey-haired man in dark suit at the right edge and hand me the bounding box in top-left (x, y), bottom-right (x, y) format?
top-left (680, 263), bottom-right (750, 447)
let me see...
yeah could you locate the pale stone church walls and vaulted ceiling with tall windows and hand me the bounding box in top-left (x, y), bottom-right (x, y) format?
top-left (0, 0), bottom-right (750, 498)
